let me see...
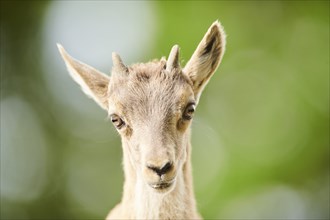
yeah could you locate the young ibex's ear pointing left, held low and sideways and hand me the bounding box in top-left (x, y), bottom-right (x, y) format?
top-left (57, 44), bottom-right (110, 110)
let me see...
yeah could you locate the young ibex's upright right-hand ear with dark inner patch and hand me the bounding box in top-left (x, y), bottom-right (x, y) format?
top-left (183, 21), bottom-right (226, 101)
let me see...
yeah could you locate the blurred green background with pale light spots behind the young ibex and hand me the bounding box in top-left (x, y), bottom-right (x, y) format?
top-left (0, 1), bottom-right (329, 219)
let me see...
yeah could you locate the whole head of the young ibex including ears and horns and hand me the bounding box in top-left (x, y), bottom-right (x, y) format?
top-left (59, 21), bottom-right (225, 193)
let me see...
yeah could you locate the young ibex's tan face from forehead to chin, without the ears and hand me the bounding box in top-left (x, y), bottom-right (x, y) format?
top-left (108, 52), bottom-right (196, 192)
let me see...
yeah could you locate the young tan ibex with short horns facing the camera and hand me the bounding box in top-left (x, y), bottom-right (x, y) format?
top-left (58, 21), bottom-right (226, 219)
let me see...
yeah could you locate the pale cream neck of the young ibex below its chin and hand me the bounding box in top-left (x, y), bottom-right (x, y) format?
top-left (118, 143), bottom-right (200, 219)
